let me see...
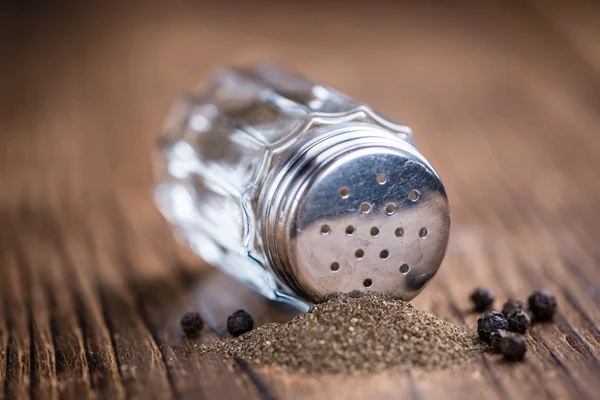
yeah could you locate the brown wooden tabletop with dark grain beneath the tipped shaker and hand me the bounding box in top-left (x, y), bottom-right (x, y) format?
top-left (0, 0), bottom-right (600, 399)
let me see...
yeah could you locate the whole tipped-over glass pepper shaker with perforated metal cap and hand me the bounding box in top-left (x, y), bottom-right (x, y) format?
top-left (154, 64), bottom-right (450, 309)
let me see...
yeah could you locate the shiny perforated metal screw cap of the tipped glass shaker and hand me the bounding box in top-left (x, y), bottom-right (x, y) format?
top-left (262, 124), bottom-right (450, 303)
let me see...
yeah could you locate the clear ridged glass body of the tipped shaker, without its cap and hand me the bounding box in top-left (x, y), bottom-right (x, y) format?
top-left (155, 66), bottom-right (414, 308)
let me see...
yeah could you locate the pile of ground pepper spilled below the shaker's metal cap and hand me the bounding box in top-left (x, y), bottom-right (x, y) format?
top-left (203, 295), bottom-right (483, 373)
